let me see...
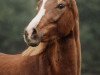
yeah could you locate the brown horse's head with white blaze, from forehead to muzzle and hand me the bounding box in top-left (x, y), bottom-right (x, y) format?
top-left (24, 0), bottom-right (77, 46)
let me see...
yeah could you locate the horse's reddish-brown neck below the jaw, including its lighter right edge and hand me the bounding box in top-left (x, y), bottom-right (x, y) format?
top-left (43, 20), bottom-right (80, 75)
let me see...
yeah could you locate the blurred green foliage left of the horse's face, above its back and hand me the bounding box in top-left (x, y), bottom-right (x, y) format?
top-left (0, 0), bottom-right (36, 53)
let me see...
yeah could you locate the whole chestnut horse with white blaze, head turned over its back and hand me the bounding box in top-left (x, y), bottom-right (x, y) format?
top-left (0, 0), bottom-right (81, 75)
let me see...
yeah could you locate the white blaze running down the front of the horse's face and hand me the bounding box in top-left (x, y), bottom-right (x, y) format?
top-left (26, 0), bottom-right (47, 33)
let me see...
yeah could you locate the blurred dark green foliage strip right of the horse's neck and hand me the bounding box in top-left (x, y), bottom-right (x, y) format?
top-left (78, 0), bottom-right (100, 75)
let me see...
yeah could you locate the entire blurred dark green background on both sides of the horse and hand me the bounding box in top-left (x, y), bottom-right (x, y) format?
top-left (0, 0), bottom-right (100, 75)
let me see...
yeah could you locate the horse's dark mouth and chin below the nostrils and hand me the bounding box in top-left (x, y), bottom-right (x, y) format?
top-left (24, 29), bottom-right (48, 47)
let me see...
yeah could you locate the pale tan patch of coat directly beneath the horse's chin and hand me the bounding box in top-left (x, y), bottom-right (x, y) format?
top-left (22, 43), bottom-right (47, 56)
